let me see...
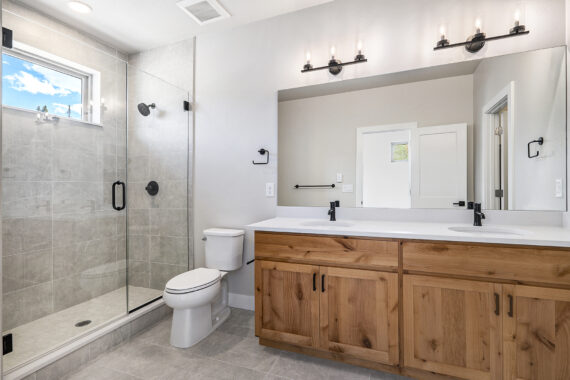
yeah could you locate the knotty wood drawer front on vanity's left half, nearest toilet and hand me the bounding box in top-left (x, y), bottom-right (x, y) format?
top-left (255, 231), bottom-right (398, 271)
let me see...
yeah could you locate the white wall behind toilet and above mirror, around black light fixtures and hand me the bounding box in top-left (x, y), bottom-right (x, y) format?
top-left (195, 0), bottom-right (565, 295)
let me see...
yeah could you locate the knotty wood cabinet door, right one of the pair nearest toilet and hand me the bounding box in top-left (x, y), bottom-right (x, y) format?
top-left (319, 267), bottom-right (398, 364)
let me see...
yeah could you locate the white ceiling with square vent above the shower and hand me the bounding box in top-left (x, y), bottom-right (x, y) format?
top-left (16, 0), bottom-right (333, 53)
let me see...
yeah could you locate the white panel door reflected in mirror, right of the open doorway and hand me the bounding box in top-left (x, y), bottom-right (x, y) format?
top-left (411, 124), bottom-right (467, 208)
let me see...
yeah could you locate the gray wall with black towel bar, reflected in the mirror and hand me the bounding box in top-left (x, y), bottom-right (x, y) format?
top-left (277, 75), bottom-right (473, 207)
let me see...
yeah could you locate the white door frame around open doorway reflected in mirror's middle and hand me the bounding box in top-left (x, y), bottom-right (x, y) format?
top-left (355, 121), bottom-right (418, 207)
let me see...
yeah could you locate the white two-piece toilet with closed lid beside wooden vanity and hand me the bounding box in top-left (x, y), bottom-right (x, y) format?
top-left (163, 228), bottom-right (244, 348)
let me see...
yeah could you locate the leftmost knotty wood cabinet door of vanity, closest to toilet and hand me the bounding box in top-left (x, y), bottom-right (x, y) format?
top-left (255, 261), bottom-right (319, 347)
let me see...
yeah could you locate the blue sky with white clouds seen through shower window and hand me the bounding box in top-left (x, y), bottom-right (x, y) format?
top-left (2, 54), bottom-right (82, 119)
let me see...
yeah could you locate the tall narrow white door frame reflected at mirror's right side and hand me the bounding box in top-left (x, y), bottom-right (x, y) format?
top-left (481, 81), bottom-right (516, 210)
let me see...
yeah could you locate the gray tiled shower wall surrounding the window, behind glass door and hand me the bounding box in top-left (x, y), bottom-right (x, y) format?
top-left (2, 0), bottom-right (126, 330)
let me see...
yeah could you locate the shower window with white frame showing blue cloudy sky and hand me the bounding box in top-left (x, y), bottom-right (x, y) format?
top-left (2, 51), bottom-right (91, 121)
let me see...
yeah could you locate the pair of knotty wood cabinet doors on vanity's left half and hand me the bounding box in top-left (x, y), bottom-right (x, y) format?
top-left (255, 260), bottom-right (398, 364)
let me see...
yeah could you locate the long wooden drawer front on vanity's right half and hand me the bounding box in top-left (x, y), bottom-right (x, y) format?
top-left (402, 241), bottom-right (570, 286)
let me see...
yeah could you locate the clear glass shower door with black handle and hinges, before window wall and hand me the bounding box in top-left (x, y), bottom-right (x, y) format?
top-left (2, 1), bottom-right (127, 372)
